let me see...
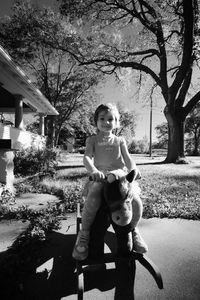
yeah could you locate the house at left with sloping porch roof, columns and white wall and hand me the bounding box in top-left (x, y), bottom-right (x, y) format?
top-left (0, 46), bottom-right (58, 189)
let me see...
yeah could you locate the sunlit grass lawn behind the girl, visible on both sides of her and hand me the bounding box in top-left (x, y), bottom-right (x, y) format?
top-left (42, 155), bottom-right (200, 220)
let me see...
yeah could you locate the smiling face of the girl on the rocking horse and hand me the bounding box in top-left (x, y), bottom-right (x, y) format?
top-left (97, 110), bottom-right (116, 133)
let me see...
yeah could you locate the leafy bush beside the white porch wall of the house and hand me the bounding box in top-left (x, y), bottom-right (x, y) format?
top-left (14, 148), bottom-right (59, 176)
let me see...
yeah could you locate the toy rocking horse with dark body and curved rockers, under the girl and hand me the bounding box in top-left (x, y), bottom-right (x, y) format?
top-left (76, 171), bottom-right (163, 300)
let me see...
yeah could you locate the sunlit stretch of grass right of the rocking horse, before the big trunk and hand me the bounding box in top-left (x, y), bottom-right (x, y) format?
top-left (140, 159), bottom-right (200, 219)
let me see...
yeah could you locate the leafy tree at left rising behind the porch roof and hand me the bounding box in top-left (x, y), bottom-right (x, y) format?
top-left (0, 1), bottom-right (100, 146)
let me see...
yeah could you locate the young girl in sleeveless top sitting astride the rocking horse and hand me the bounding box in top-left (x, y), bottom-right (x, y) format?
top-left (72, 103), bottom-right (148, 260)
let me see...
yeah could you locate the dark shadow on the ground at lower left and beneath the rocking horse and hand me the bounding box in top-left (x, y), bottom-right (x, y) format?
top-left (0, 232), bottom-right (135, 300)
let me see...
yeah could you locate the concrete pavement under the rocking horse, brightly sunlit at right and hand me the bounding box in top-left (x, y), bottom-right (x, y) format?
top-left (18, 214), bottom-right (200, 300)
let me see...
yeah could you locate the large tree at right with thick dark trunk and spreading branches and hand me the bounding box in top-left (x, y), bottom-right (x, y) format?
top-left (58, 0), bottom-right (200, 162)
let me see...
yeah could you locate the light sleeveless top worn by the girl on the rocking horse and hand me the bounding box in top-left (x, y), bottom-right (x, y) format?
top-left (85, 134), bottom-right (126, 173)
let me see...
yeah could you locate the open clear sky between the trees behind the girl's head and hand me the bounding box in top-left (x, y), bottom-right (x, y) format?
top-left (0, 0), bottom-right (166, 142)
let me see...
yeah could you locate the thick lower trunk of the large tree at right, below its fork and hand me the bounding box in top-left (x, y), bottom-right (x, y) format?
top-left (165, 110), bottom-right (185, 163)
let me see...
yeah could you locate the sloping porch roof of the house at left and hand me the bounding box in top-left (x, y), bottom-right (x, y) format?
top-left (0, 46), bottom-right (58, 115)
